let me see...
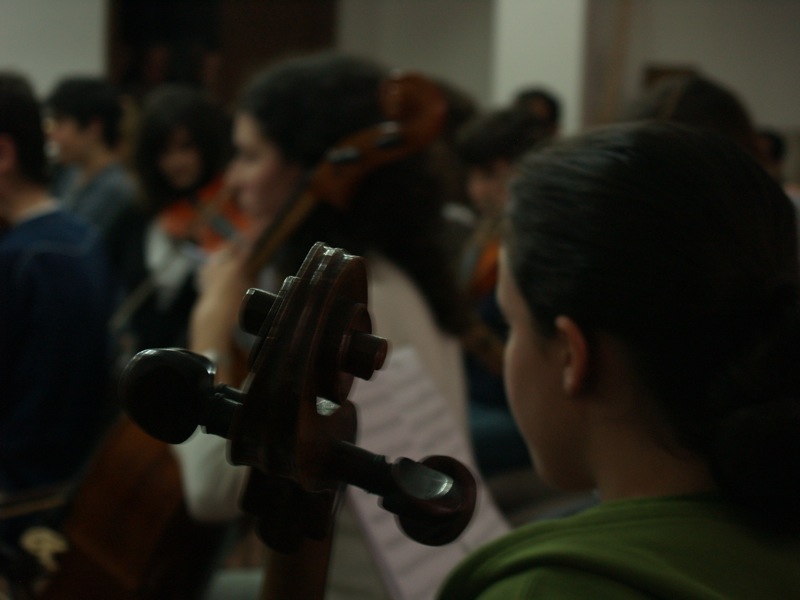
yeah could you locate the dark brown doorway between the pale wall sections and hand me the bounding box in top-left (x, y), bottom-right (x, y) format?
top-left (108, 0), bottom-right (337, 106)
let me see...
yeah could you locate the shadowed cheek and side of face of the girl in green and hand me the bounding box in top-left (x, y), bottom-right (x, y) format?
top-left (497, 247), bottom-right (591, 489)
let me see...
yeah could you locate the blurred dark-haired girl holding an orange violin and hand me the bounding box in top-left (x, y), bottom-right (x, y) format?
top-left (112, 84), bottom-right (248, 355)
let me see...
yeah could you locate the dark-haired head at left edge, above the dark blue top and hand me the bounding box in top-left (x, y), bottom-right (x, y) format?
top-left (0, 72), bottom-right (47, 184)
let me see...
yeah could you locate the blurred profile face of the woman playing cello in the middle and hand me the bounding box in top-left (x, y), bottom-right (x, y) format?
top-left (228, 113), bottom-right (303, 221)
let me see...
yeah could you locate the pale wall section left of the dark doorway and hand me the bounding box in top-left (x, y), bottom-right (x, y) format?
top-left (0, 0), bottom-right (106, 95)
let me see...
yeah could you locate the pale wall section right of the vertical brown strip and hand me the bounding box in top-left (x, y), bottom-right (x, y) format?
top-left (624, 0), bottom-right (800, 127)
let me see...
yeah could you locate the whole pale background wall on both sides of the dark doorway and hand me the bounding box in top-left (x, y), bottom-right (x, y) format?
top-left (0, 0), bottom-right (800, 136)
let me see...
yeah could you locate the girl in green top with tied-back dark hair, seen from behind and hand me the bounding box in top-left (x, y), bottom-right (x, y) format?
top-left (441, 124), bottom-right (800, 600)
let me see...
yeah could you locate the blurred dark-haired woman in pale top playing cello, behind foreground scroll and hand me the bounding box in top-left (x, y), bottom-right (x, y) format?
top-left (176, 55), bottom-right (484, 598)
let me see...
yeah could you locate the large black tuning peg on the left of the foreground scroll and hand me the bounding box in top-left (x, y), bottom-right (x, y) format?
top-left (120, 348), bottom-right (241, 444)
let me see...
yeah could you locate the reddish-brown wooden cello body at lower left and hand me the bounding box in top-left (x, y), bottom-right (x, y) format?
top-left (37, 416), bottom-right (226, 600)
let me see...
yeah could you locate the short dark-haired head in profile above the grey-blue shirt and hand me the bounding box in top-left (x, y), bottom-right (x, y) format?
top-left (46, 77), bottom-right (122, 164)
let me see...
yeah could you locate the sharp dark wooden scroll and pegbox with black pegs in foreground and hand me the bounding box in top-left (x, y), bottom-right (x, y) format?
top-left (121, 243), bottom-right (477, 600)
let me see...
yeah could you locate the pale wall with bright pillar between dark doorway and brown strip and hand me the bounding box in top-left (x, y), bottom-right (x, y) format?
top-left (337, 0), bottom-right (586, 130)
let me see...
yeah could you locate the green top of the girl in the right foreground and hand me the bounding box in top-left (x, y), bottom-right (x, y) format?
top-left (439, 495), bottom-right (800, 600)
